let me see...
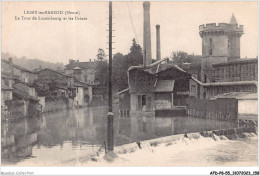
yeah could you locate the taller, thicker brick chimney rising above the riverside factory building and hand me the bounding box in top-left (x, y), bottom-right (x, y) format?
top-left (143, 1), bottom-right (152, 66)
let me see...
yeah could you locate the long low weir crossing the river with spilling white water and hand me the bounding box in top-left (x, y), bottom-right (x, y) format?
top-left (50, 127), bottom-right (257, 166)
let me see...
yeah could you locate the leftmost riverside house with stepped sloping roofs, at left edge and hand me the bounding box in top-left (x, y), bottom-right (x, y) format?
top-left (1, 58), bottom-right (41, 118)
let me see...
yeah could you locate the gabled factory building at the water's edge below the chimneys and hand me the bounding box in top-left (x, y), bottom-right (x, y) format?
top-left (118, 59), bottom-right (191, 116)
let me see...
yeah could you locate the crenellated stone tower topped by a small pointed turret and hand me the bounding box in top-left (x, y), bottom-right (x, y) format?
top-left (199, 14), bottom-right (243, 64)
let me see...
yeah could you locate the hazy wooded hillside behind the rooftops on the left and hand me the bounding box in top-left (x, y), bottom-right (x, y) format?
top-left (1, 53), bottom-right (64, 70)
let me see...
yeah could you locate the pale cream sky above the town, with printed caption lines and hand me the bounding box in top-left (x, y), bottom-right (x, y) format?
top-left (2, 1), bottom-right (258, 64)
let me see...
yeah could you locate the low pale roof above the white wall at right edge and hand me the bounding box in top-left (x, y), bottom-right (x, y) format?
top-left (210, 92), bottom-right (258, 100)
